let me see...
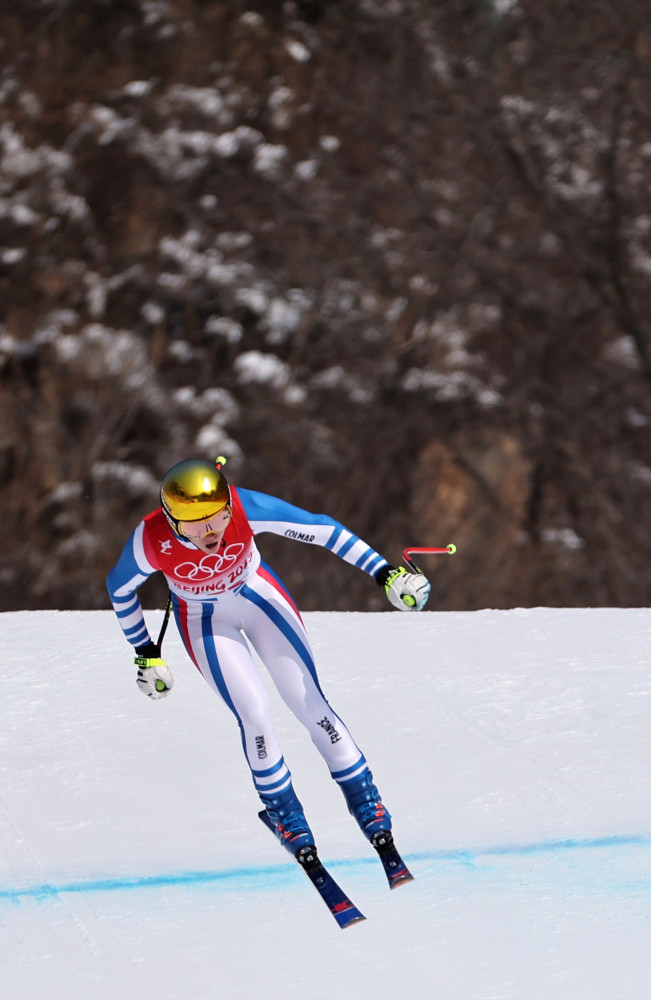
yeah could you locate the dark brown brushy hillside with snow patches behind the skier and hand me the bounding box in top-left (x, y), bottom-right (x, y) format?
top-left (0, 0), bottom-right (651, 610)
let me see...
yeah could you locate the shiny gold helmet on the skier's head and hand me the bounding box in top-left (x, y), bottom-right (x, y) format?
top-left (160, 458), bottom-right (231, 529)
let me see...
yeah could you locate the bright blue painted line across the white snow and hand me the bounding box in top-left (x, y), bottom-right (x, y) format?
top-left (0, 836), bottom-right (651, 902)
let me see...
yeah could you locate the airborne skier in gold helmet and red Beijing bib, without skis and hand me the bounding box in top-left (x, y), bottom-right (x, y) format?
top-left (107, 458), bottom-right (430, 856)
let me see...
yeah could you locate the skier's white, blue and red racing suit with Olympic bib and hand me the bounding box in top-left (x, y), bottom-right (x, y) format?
top-left (107, 487), bottom-right (388, 795)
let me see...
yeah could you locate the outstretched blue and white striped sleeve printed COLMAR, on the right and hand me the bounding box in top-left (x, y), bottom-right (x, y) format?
top-left (237, 489), bottom-right (388, 576)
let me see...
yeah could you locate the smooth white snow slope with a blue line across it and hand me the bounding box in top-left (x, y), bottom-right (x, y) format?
top-left (0, 609), bottom-right (651, 1000)
